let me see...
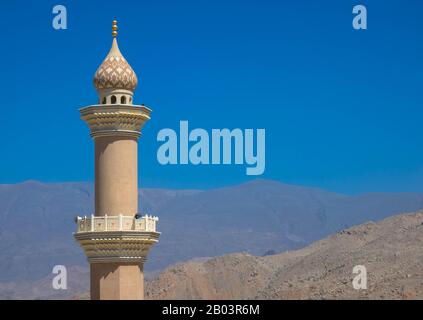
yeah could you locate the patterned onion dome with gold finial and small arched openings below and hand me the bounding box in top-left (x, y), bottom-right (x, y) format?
top-left (94, 20), bottom-right (138, 104)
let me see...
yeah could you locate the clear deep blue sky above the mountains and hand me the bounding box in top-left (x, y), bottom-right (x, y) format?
top-left (0, 0), bottom-right (423, 193)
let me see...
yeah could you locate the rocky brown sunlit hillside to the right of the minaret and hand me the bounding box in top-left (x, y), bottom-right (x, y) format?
top-left (146, 212), bottom-right (423, 299)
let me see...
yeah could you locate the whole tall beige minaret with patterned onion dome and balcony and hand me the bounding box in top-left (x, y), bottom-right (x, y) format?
top-left (74, 20), bottom-right (159, 300)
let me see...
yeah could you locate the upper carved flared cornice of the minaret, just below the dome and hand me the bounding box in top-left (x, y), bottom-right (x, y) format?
top-left (80, 105), bottom-right (151, 138)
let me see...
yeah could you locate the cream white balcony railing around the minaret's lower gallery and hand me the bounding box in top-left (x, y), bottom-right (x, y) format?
top-left (76, 215), bottom-right (159, 233)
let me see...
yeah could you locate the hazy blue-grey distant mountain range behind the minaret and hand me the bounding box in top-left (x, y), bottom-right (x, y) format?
top-left (0, 180), bottom-right (423, 298)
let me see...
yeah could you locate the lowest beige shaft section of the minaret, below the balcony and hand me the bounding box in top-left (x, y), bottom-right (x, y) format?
top-left (90, 262), bottom-right (144, 300)
